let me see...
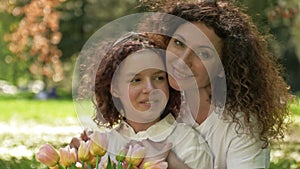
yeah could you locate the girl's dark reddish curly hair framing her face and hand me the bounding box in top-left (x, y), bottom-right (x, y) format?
top-left (88, 33), bottom-right (181, 128)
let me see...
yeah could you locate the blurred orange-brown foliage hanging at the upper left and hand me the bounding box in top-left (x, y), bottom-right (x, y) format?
top-left (4, 0), bottom-right (63, 88)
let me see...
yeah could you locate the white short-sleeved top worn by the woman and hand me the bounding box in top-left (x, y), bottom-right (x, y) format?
top-left (195, 112), bottom-right (270, 169)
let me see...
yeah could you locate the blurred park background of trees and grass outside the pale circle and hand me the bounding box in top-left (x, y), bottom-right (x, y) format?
top-left (0, 0), bottom-right (300, 169)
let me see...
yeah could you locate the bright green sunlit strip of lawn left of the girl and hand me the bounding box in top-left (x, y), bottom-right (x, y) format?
top-left (0, 99), bottom-right (77, 124)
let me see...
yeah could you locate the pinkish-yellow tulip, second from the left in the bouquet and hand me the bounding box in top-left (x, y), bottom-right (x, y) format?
top-left (59, 146), bottom-right (77, 167)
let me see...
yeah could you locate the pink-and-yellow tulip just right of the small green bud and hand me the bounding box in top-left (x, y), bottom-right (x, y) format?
top-left (125, 144), bottom-right (146, 166)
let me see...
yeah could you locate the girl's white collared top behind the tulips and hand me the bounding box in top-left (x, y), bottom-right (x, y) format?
top-left (108, 114), bottom-right (213, 169)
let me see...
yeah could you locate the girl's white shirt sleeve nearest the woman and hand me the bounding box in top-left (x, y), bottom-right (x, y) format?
top-left (173, 126), bottom-right (213, 169)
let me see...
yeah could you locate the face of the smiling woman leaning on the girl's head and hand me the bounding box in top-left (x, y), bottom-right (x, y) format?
top-left (166, 23), bottom-right (222, 90)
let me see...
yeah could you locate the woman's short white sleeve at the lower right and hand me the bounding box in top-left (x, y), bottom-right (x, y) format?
top-left (227, 134), bottom-right (270, 169)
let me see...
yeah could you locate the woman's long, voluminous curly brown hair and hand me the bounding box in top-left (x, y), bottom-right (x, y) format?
top-left (156, 1), bottom-right (291, 144)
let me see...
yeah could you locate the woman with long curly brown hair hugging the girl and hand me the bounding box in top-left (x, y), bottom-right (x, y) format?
top-left (145, 1), bottom-right (290, 169)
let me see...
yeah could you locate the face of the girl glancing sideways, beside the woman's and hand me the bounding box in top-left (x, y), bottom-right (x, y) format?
top-left (111, 49), bottom-right (169, 123)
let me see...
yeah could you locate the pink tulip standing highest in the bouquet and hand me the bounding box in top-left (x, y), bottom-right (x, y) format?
top-left (90, 131), bottom-right (108, 157)
